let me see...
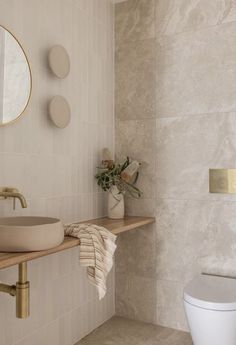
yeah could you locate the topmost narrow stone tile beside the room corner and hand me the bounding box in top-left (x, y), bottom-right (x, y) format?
top-left (115, 0), bottom-right (155, 43)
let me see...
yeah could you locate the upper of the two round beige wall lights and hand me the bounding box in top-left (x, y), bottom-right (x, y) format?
top-left (48, 45), bottom-right (70, 79)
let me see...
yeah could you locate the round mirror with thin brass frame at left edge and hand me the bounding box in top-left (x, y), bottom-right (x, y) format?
top-left (0, 26), bottom-right (32, 126)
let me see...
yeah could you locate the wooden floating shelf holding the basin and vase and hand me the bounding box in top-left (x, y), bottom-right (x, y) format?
top-left (0, 217), bottom-right (155, 269)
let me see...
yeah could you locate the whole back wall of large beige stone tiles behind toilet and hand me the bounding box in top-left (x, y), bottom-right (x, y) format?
top-left (115, 0), bottom-right (236, 329)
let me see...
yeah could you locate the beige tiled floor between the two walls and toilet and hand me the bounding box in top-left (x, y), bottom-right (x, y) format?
top-left (76, 317), bottom-right (192, 345)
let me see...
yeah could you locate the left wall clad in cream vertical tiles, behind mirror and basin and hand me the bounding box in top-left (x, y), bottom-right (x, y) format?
top-left (0, 0), bottom-right (114, 345)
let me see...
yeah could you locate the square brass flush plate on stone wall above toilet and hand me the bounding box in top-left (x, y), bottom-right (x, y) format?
top-left (209, 169), bottom-right (236, 194)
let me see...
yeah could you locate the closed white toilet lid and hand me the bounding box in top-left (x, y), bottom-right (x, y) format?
top-left (184, 275), bottom-right (236, 311)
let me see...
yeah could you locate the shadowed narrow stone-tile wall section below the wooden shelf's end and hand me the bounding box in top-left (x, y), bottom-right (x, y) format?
top-left (116, 224), bottom-right (158, 324)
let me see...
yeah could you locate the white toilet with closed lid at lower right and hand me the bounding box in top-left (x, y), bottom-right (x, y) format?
top-left (184, 275), bottom-right (236, 345)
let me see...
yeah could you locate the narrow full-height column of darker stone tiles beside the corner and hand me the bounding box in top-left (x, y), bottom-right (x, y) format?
top-left (115, 0), bottom-right (157, 323)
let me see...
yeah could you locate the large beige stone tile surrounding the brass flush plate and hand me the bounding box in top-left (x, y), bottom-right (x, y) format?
top-left (156, 113), bottom-right (236, 200)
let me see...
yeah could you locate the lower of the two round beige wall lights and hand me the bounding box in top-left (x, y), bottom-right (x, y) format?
top-left (48, 96), bottom-right (71, 128)
